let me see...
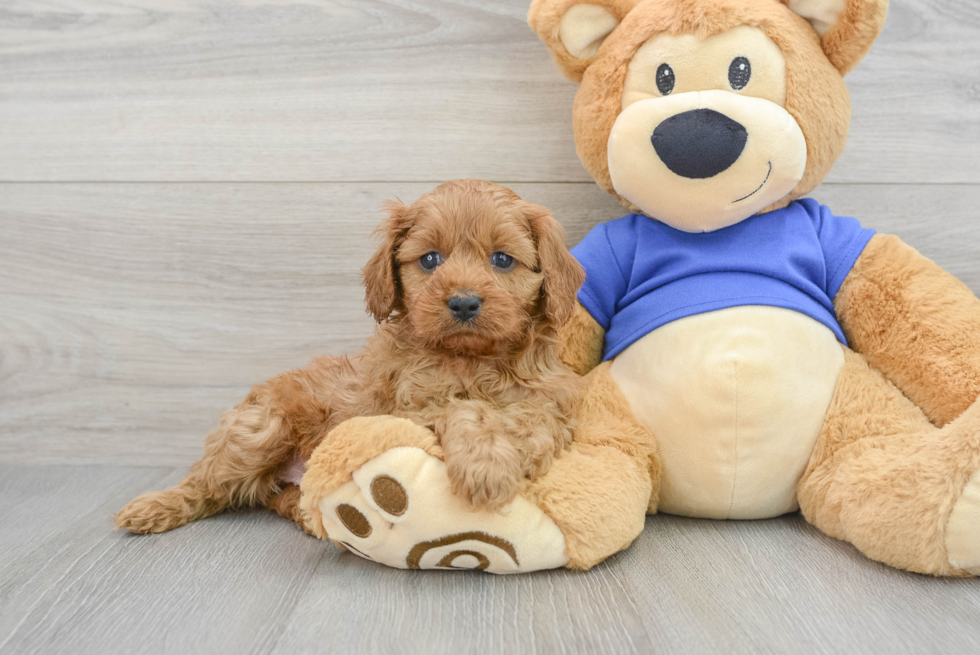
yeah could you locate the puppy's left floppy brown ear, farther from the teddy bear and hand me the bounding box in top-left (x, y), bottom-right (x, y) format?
top-left (361, 200), bottom-right (411, 323)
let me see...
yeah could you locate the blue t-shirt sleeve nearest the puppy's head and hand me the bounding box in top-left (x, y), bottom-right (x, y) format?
top-left (572, 224), bottom-right (626, 330)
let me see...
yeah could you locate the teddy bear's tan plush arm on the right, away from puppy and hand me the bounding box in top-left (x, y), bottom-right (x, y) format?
top-left (834, 234), bottom-right (980, 425)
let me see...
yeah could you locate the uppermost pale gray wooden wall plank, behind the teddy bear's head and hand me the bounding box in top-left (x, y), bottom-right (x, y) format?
top-left (0, 0), bottom-right (980, 183)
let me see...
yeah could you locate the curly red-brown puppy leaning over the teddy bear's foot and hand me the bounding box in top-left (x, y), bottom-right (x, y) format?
top-left (116, 180), bottom-right (584, 532)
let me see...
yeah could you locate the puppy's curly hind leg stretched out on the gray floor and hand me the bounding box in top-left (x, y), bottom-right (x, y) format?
top-left (116, 400), bottom-right (293, 533)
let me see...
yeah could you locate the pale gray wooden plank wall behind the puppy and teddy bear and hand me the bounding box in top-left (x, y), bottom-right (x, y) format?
top-left (0, 0), bottom-right (980, 466)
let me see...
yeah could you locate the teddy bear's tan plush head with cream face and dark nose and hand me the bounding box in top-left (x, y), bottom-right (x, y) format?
top-left (528, 0), bottom-right (888, 232)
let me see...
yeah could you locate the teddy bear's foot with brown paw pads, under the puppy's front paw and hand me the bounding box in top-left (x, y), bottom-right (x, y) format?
top-left (300, 416), bottom-right (568, 573)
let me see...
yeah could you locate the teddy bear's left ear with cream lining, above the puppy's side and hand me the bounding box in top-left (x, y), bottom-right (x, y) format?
top-left (527, 0), bottom-right (639, 82)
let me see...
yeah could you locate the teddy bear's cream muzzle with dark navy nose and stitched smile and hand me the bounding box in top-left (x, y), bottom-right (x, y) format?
top-left (608, 90), bottom-right (807, 232)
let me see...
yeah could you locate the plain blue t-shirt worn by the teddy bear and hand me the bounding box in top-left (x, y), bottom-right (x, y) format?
top-left (572, 198), bottom-right (874, 359)
